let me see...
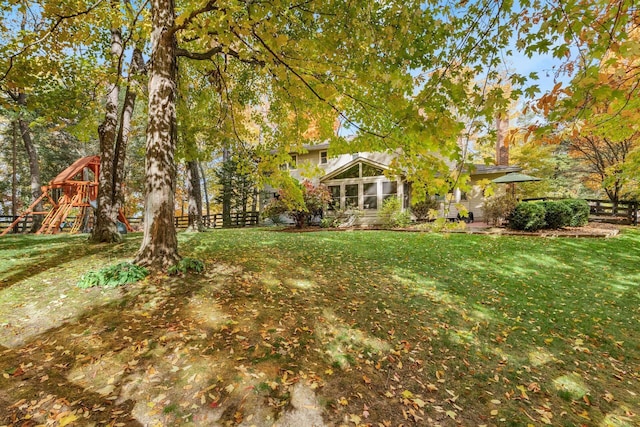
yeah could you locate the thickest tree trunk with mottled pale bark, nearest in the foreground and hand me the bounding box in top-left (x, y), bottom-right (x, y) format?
top-left (136, 0), bottom-right (180, 270)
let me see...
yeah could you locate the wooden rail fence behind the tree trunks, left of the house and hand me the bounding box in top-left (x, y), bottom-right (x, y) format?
top-left (0, 211), bottom-right (260, 233)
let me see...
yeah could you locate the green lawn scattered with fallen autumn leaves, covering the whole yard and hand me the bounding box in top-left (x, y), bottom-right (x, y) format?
top-left (0, 229), bottom-right (640, 426)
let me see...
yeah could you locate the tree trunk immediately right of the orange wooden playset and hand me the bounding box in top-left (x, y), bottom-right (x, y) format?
top-left (90, 28), bottom-right (123, 243)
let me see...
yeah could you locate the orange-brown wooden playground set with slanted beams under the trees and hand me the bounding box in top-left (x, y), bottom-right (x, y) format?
top-left (0, 156), bottom-right (133, 236)
